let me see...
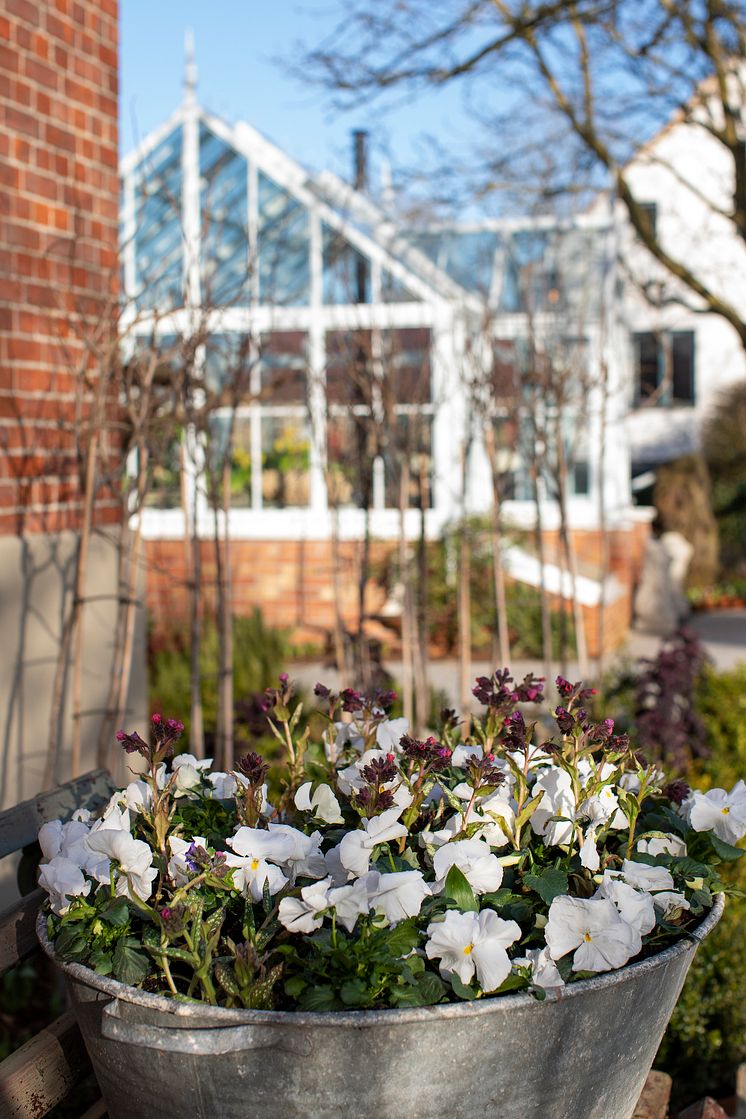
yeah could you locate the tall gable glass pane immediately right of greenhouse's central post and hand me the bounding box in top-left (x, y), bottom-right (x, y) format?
top-left (199, 124), bottom-right (249, 307)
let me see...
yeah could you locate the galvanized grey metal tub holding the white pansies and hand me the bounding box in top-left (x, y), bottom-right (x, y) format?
top-left (37, 897), bottom-right (723, 1119)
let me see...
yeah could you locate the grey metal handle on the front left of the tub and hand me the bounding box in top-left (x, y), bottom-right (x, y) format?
top-left (101, 999), bottom-right (312, 1056)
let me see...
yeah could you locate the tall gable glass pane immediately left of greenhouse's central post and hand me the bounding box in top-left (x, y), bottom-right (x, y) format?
top-left (134, 129), bottom-right (183, 310)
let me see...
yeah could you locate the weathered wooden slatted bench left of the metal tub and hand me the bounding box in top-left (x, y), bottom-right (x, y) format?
top-left (0, 770), bottom-right (114, 1119)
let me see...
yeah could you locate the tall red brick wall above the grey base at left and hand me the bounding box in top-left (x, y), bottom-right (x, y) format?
top-left (0, 0), bottom-right (119, 534)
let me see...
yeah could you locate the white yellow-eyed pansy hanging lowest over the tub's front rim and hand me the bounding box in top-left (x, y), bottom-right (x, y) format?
top-left (425, 910), bottom-right (521, 994)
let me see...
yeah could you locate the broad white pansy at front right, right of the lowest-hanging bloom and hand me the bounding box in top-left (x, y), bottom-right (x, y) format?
top-left (545, 894), bottom-right (642, 971)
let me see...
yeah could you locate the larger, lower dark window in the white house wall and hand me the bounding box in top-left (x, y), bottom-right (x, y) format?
top-left (634, 330), bottom-right (695, 405)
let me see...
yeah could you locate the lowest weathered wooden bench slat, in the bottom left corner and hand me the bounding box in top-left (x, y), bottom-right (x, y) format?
top-left (0, 1010), bottom-right (91, 1119)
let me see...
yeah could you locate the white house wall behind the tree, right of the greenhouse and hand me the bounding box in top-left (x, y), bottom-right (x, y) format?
top-left (620, 107), bottom-right (746, 464)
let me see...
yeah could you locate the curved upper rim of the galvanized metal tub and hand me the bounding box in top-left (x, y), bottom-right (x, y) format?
top-left (36, 894), bottom-right (725, 1028)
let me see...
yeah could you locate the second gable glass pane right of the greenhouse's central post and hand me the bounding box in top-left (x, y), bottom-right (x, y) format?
top-left (258, 172), bottom-right (311, 307)
